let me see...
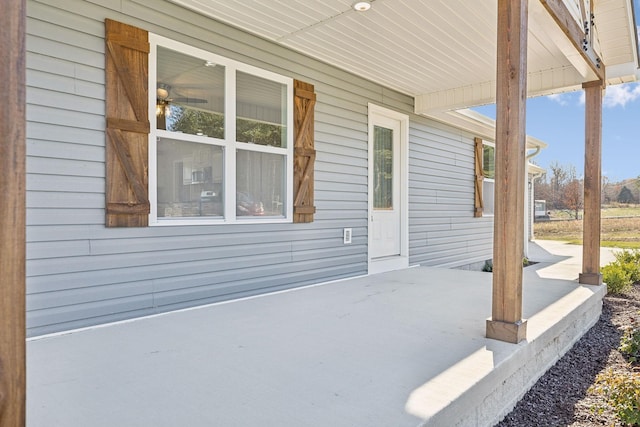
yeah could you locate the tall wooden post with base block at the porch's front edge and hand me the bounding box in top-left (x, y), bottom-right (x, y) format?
top-left (487, 0), bottom-right (528, 343)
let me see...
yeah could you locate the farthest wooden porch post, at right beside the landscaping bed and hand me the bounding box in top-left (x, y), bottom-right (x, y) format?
top-left (579, 81), bottom-right (604, 285)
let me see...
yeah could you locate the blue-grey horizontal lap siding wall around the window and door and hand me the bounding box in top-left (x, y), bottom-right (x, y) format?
top-left (27, 0), bottom-right (492, 336)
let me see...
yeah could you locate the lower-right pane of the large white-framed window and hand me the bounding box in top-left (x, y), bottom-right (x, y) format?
top-left (236, 150), bottom-right (286, 216)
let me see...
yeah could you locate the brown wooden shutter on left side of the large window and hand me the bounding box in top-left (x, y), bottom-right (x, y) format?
top-left (105, 19), bottom-right (150, 227)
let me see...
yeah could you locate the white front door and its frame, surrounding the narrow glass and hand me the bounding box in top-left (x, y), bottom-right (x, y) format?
top-left (367, 103), bottom-right (409, 274)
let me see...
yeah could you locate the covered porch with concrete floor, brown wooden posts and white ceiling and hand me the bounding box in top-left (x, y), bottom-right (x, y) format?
top-left (0, 0), bottom-right (638, 426)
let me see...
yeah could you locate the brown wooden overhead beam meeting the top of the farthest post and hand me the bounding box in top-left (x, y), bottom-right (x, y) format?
top-left (540, 0), bottom-right (605, 81)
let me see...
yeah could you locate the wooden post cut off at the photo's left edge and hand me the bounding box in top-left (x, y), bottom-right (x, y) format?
top-left (0, 0), bottom-right (26, 427)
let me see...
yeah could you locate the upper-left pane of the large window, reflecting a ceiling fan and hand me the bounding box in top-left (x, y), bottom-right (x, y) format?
top-left (156, 46), bottom-right (225, 138)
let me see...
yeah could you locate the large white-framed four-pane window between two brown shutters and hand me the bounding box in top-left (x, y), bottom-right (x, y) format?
top-left (149, 35), bottom-right (293, 224)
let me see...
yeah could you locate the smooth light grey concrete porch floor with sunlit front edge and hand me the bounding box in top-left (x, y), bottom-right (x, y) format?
top-left (27, 242), bottom-right (612, 427)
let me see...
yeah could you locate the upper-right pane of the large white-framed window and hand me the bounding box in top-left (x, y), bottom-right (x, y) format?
top-left (236, 72), bottom-right (287, 148)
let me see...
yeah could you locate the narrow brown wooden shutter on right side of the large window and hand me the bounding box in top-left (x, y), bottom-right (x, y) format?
top-left (293, 80), bottom-right (316, 222)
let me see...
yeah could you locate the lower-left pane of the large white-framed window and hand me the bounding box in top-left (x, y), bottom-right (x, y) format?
top-left (158, 138), bottom-right (224, 217)
